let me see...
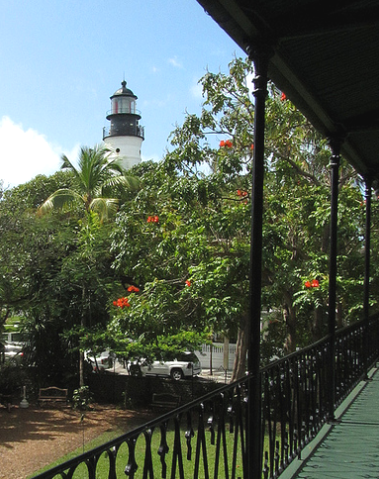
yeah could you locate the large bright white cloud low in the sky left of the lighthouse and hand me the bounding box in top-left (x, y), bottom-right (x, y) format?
top-left (0, 116), bottom-right (67, 187)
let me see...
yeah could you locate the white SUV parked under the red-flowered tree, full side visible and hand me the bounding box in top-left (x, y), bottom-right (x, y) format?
top-left (128, 352), bottom-right (201, 380)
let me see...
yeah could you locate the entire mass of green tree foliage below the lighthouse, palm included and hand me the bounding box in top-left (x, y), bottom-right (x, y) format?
top-left (0, 59), bottom-right (379, 386)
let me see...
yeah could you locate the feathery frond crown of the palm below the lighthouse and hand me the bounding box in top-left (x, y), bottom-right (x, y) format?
top-left (40, 145), bottom-right (136, 220)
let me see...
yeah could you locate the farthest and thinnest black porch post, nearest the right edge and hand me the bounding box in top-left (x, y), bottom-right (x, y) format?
top-left (363, 176), bottom-right (372, 379)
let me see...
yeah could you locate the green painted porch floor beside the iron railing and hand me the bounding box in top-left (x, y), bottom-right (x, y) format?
top-left (292, 370), bottom-right (379, 479)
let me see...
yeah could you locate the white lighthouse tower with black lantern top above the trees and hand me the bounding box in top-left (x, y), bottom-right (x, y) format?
top-left (103, 80), bottom-right (145, 169)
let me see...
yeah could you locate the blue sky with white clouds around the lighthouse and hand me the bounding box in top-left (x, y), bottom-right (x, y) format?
top-left (0, 0), bottom-right (245, 187)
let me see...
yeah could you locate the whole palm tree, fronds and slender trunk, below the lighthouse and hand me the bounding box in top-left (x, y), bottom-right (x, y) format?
top-left (39, 146), bottom-right (140, 386)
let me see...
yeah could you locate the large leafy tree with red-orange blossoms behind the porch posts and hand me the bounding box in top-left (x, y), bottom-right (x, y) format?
top-left (108, 59), bottom-right (362, 378)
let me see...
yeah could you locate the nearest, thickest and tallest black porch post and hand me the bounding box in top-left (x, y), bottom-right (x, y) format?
top-left (245, 45), bottom-right (270, 479)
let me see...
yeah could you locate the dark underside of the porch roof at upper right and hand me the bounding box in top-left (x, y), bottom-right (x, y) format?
top-left (197, 0), bottom-right (379, 179)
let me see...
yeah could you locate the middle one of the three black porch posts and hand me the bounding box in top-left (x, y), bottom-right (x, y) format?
top-left (327, 138), bottom-right (341, 421)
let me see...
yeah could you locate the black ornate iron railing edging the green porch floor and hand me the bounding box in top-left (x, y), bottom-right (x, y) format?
top-left (31, 318), bottom-right (379, 479)
